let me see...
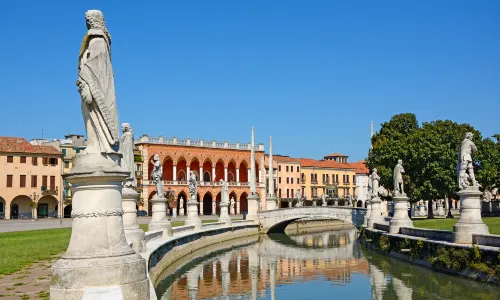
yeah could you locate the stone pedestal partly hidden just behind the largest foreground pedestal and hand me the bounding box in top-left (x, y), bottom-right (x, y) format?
top-left (122, 187), bottom-right (146, 253)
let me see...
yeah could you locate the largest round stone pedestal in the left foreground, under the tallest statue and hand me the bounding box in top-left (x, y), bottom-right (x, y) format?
top-left (50, 153), bottom-right (149, 300)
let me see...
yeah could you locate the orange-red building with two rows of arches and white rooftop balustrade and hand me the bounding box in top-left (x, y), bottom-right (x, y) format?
top-left (135, 135), bottom-right (266, 215)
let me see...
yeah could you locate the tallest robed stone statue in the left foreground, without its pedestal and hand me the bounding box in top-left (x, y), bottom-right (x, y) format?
top-left (76, 10), bottom-right (119, 156)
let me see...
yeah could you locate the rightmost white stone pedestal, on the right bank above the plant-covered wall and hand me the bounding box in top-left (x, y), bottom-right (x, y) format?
top-left (453, 186), bottom-right (489, 244)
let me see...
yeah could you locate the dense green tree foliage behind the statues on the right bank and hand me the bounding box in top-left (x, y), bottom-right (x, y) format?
top-left (366, 113), bottom-right (500, 202)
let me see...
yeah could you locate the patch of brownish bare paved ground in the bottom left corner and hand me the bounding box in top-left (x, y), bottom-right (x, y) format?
top-left (0, 257), bottom-right (58, 300)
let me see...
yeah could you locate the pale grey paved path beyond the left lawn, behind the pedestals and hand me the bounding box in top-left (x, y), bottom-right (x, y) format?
top-left (0, 216), bottom-right (239, 232)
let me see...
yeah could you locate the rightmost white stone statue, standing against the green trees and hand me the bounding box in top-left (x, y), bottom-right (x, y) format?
top-left (457, 132), bottom-right (478, 189)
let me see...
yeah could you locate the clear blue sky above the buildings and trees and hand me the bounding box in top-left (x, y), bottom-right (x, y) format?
top-left (0, 0), bottom-right (500, 160)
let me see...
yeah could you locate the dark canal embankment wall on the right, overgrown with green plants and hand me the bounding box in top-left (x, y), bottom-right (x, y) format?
top-left (360, 223), bottom-right (500, 284)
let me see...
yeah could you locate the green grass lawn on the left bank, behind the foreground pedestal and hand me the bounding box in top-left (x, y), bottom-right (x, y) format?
top-left (0, 220), bottom-right (221, 275)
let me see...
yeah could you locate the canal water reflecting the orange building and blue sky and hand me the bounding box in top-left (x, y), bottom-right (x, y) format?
top-left (155, 227), bottom-right (500, 300)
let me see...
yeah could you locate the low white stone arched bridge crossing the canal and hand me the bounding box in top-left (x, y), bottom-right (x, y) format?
top-left (258, 206), bottom-right (366, 232)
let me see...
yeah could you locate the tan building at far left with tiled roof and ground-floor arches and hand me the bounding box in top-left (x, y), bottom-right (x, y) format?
top-left (0, 137), bottom-right (63, 219)
